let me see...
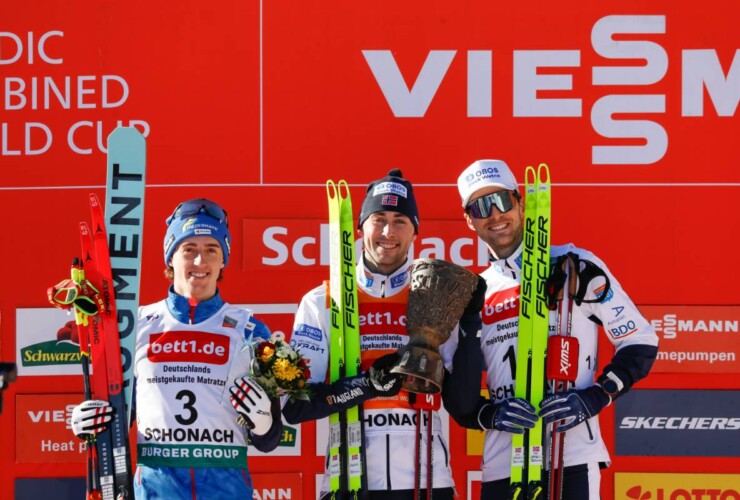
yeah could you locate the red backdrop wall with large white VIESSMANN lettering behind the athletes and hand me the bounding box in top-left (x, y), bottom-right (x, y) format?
top-left (0, 0), bottom-right (740, 498)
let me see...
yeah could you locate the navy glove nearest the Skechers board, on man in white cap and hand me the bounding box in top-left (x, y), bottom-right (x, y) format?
top-left (540, 385), bottom-right (612, 432)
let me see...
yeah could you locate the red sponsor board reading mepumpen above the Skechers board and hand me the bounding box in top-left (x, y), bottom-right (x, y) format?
top-left (640, 306), bottom-right (740, 373)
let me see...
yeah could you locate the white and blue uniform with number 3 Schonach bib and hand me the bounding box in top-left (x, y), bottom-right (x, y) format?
top-left (134, 289), bottom-right (281, 499)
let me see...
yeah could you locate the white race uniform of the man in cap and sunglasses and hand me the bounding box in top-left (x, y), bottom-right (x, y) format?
top-left (466, 244), bottom-right (658, 498)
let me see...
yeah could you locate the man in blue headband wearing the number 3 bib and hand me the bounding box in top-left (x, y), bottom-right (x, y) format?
top-left (72, 199), bottom-right (282, 499)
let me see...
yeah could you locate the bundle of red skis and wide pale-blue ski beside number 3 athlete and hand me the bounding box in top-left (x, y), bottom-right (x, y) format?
top-left (72, 127), bottom-right (146, 500)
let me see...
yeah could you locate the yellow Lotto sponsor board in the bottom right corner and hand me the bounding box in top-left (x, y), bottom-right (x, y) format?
top-left (614, 472), bottom-right (740, 500)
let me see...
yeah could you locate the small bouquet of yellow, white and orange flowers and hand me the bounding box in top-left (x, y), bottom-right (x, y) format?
top-left (251, 336), bottom-right (311, 400)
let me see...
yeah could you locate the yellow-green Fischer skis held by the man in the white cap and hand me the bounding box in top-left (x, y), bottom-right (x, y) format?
top-left (510, 163), bottom-right (550, 500)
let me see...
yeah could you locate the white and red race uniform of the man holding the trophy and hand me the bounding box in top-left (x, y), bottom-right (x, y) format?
top-left (283, 258), bottom-right (468, 495)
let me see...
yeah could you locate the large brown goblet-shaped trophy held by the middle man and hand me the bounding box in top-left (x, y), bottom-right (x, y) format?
top-left (391, 259), bottom-right (478, 394)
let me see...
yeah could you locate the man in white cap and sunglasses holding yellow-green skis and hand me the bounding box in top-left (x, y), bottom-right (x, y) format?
top-left (450, 160), bottom-right (658, 500)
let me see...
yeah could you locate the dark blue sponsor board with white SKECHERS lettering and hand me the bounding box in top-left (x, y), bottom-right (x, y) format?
top-left (615, 389), bottom-right (740, 457)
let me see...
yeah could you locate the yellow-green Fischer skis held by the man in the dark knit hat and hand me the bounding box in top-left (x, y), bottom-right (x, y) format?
top-left (326, 180), bottom-right (367, 500)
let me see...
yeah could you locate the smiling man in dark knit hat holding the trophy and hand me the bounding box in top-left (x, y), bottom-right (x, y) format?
top-left (283, 170), bottom-right (485, 500)
